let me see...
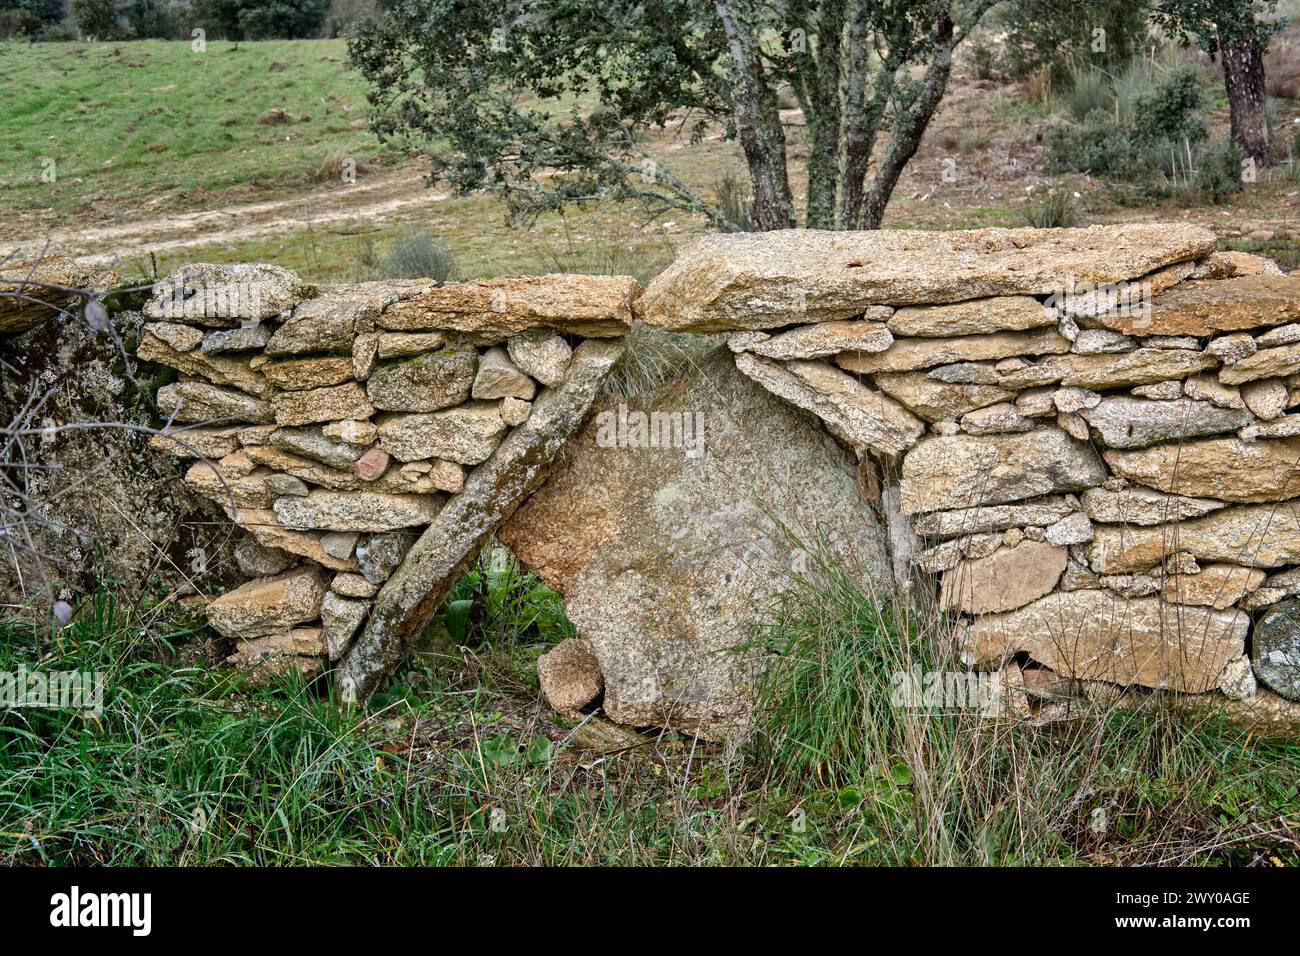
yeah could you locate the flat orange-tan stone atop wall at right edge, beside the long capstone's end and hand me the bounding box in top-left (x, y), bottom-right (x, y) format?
top-left (1084, 274), bottom-right (1300, 336)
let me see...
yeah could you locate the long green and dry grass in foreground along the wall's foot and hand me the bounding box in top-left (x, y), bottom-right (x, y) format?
top-left (0, 546), bottom-right (1300, 865)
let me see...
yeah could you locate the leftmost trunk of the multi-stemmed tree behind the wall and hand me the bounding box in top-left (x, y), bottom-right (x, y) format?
top-left (715, 0), bottom-right (796, 232)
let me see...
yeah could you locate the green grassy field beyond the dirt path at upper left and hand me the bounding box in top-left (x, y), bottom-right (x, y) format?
top-left (0, 40), bottom-right (380, 216)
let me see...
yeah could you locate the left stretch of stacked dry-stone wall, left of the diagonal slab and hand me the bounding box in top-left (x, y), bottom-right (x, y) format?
top-left (138, 265), bottom-right (640, 674)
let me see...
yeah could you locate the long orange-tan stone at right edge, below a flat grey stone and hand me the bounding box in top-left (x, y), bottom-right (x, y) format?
top-left (1104, 438), bottom-right (1300, 502)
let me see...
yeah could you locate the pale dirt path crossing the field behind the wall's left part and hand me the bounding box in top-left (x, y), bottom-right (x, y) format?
top-left (5, 168), bottom-right (447, 263)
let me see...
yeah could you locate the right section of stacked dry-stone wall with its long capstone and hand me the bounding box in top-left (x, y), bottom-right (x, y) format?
top-left (638, 225), bottom-right (1300, 700)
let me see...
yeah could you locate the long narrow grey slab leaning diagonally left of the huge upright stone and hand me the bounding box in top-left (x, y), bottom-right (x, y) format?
top-left (339, 341), bottom-right (623, 702)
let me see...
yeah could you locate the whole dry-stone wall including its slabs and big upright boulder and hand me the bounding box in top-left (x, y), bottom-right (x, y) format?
top-left (22, 224), bottom-right (1300, 735)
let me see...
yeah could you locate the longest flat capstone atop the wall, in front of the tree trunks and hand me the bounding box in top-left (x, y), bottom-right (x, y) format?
top-left (637, 224), bottom-right (1214, 332)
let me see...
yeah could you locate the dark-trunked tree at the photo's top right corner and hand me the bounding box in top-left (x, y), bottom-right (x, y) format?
top-left (1156, 0), bottom-right (1286, 166)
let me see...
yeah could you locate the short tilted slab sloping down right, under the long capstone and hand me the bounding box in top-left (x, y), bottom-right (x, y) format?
top-left (736, 352), bottom-right (926, 455)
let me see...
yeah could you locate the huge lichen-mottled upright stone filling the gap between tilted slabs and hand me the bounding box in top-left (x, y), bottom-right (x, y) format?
top-left (493, 351), bottom-right (892, 737)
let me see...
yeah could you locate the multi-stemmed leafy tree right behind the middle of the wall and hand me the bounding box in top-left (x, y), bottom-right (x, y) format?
top-left (350, 0), bottom-right (993, 230)
